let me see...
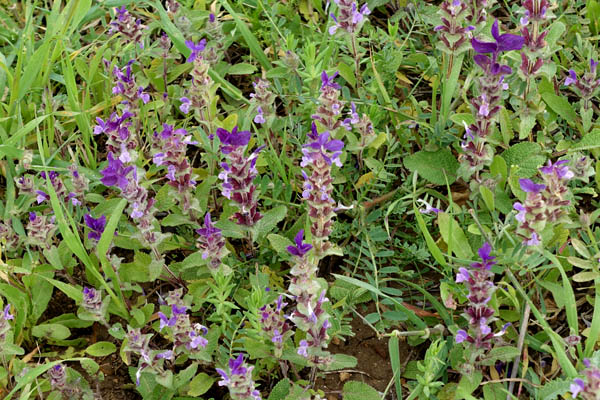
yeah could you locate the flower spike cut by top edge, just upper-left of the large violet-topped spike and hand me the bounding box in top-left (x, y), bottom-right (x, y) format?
top-left (434, 0), bottom-right (475, 54)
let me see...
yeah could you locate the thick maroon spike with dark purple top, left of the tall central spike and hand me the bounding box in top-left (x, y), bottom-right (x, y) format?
top-left (217, 126), bottom-right (264, 227)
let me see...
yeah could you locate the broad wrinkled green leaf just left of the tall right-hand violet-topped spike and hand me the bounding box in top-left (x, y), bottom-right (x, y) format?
top-left (404, 149), bottom-right (459, 185)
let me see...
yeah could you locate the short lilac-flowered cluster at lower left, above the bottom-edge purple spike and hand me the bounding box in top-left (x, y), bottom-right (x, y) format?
top-left (158, 296), bottom-right (208, 358)
